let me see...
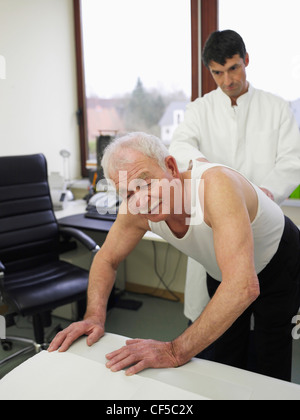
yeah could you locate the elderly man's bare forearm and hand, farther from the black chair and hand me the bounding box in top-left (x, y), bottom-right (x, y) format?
top-left (106, 274), bottom-right (258, 375)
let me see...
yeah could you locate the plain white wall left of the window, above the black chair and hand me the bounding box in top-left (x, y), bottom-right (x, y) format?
top-left (0, 0), bottom-right (80, 177)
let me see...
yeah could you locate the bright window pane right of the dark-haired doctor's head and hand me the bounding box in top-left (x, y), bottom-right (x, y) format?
top-left (219, 0), bottom-right (300, 101)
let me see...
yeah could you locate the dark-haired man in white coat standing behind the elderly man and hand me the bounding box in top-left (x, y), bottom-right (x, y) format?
top-left (169, 30), bottom-right (300, 330)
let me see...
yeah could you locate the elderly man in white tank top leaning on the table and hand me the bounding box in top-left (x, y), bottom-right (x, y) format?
top-left (49, 133), bottom-right (300, 380)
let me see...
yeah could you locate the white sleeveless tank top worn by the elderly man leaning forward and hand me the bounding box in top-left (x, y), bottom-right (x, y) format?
top-left (149, 160), bottom-right (284, 281)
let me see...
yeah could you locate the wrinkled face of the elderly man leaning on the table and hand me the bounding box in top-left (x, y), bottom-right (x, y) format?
top-left (112, 150), bottom-right (181, 222)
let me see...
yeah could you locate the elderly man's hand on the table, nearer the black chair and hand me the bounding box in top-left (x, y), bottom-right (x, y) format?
top-left (48, 318), bottom-right (104, 352)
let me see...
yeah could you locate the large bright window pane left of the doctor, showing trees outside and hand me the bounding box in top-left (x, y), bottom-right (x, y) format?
top-left (74, 0), bottom-right (195, 172)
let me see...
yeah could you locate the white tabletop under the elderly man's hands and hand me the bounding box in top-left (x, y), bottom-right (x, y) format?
top-left (0, 334), bottom-right (300, 401)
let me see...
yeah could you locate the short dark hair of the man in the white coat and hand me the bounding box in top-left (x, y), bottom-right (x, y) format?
top-left (202, 29), bottom-right (247, 68)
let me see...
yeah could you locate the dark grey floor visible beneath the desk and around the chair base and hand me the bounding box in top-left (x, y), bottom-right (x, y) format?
top-left (0, 293), bottom-right (300, 384)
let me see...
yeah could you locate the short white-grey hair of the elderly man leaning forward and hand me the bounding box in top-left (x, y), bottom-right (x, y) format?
top-left (101, 132), bottom-right (169, 179)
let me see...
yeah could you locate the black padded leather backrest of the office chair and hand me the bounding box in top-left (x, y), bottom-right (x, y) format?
top-left (0, 154), bottom-right (58, 273)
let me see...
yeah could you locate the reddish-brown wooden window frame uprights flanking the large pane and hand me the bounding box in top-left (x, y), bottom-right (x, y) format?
top-left (73, 0), bottom-right (218, 177)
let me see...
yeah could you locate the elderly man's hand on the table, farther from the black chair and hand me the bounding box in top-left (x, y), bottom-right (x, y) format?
top-left (106, 339), bottom-right (179, 376)
